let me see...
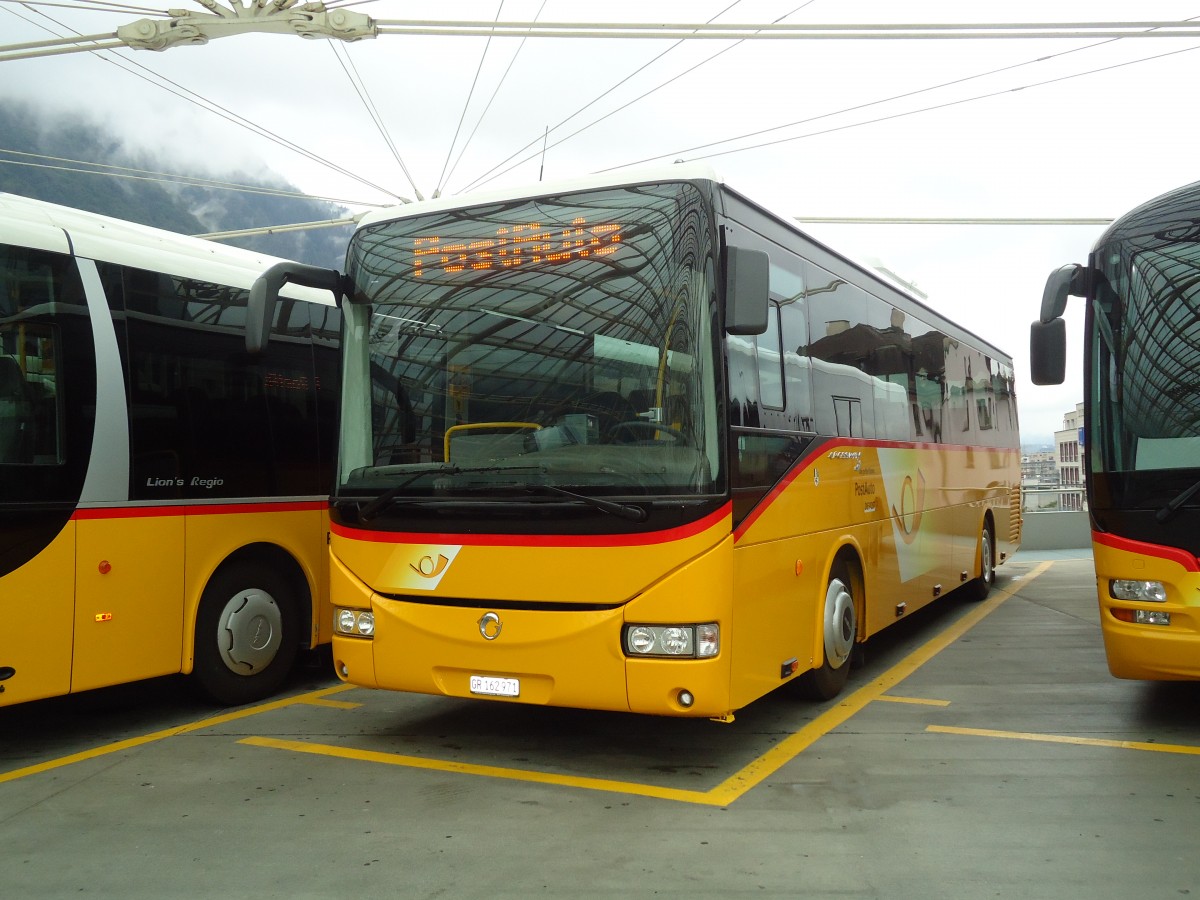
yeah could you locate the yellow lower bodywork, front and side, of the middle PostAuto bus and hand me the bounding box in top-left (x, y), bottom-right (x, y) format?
top-left (331, 442), bottom-right (1019, 716)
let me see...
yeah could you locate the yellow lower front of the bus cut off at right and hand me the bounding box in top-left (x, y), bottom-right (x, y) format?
top-left (1092, 539), bottom-right (1200, 680)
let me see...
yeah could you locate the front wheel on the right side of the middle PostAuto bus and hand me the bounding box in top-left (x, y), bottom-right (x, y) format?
top-left (799, 547), bottom-right (864, 700)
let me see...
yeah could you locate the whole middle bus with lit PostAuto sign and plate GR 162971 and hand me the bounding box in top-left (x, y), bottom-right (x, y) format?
top-left (247, 166), bottom-right (1020, 720)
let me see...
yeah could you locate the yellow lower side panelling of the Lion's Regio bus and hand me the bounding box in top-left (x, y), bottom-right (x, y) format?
top-left (0, 502), bottom-right (332, 706)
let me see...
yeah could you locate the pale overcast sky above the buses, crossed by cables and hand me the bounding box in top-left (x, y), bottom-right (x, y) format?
top-left (0, 0), bottom-right (1200, 444)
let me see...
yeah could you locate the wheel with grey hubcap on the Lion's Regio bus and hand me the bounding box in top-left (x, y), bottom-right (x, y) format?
top-left (192, 562), bottom-right (298, 706)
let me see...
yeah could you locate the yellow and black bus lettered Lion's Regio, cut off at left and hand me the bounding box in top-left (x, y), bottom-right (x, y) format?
top-left (0, 194), bottom-right (341, 706)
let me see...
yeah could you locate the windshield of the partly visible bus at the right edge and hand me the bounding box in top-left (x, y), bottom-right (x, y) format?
top-left (1090, 228), bottom-right (1200, 487)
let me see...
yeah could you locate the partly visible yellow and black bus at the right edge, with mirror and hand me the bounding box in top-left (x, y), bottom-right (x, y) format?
top-left (1030, 184), bottom-right (1200, 680)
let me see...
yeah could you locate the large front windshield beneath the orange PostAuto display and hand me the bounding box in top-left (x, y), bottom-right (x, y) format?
top-left (336, 184), bottom-right (722, 514)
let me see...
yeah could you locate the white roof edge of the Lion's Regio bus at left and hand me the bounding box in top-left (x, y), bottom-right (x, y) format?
top-left (0, 193), bottom-right (334, 306)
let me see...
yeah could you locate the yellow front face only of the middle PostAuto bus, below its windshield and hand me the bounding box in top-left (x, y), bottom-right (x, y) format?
top-left (331, 516), bottom-right (732, 715)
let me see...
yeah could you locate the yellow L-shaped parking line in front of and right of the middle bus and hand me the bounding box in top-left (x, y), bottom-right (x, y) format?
top-left (240, 562), bottom-right (1050, 806)
